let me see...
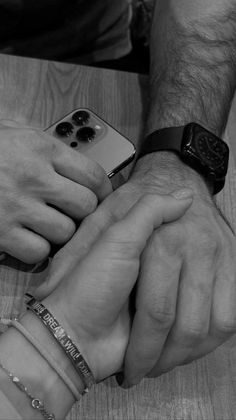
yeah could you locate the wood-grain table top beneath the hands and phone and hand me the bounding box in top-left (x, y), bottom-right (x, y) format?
top-left (0, 52), bottom-right (236, 420)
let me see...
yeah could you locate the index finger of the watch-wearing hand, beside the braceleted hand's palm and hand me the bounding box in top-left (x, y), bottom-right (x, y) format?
top-left (124, 238), bottom-right (181, 386)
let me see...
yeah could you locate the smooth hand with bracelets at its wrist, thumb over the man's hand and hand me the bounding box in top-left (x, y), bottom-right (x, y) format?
top-left (43, 190), bottom-right (192, 381)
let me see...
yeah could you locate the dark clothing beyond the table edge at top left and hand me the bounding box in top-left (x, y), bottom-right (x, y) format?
top-left (0, 0), bottom-right (131, 64)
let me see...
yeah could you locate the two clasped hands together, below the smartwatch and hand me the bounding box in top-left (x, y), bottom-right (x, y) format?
top-left (38, 158), bottom-right (236, 385)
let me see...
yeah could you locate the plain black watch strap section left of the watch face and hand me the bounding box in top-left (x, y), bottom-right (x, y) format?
top-left (138, 126), bottom-right (185, 158)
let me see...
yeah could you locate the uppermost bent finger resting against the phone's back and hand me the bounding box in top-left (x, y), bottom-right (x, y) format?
top-left (53, 142), bottom-right (112, 201)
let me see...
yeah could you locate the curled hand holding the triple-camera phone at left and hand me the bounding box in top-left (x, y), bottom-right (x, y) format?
top-left (0, 121), bottom-right (112, 264)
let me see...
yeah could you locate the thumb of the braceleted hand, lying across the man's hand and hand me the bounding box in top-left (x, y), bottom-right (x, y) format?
top-left (77, 194), bottom-right (194, 270)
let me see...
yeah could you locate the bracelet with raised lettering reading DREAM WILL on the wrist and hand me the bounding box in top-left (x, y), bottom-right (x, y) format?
top-left (26, 293), bottom-right (96, 394)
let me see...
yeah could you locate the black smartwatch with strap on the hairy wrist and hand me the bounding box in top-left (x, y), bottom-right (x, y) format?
top-left (139, 122), bottom-right (229, 194)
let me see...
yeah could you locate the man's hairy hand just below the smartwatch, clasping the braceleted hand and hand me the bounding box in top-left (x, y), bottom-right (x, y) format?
top-left (38, 154), bottom-right (236, 384)
